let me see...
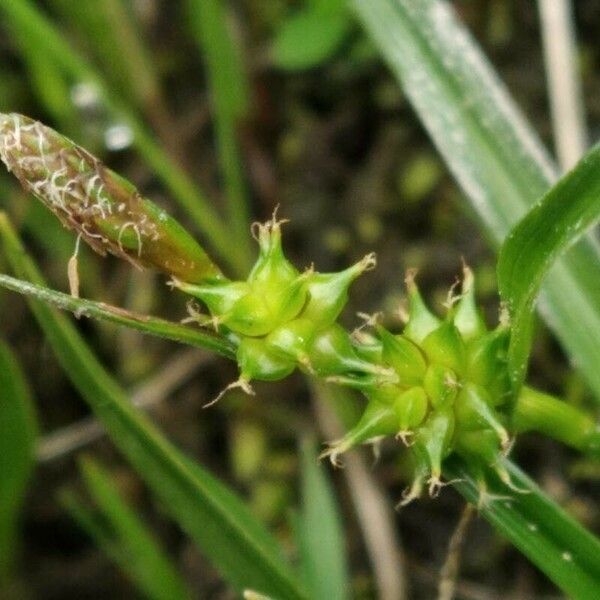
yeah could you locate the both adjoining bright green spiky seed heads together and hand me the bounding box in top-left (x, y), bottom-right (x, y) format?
top-left (174, 218), bottom-right (510, 502)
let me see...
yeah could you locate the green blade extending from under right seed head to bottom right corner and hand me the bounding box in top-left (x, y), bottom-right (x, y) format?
top-left (445, 457), bottom-right (600, 600)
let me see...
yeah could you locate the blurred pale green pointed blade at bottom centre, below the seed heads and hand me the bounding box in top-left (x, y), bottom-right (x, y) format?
top-left (297, 442), bottom-right (350, 600)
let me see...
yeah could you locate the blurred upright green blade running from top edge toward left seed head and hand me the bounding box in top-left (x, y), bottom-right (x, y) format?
top-left (187, 0), bottom-right (252, 265)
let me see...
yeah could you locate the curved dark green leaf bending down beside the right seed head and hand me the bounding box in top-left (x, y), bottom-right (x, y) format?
top-left (498, 146), bottom-right (600, 387)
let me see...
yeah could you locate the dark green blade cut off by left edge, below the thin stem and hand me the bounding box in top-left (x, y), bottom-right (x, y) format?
top-left (0, 340), bottom-right (37, 580)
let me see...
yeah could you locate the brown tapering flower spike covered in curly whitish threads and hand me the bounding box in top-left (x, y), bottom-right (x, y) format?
top-left (0, 113), bottom-right (220, 281)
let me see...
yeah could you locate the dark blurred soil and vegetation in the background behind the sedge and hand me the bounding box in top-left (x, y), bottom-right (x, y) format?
top-left (0, 0), bottom-right (600, 600)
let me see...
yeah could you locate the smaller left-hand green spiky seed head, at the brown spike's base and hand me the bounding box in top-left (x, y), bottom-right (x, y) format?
top-left (173, 217), bottom-right (390, 389)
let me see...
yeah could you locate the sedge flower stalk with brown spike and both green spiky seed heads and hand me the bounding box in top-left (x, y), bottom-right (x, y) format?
top-left (0, 113), bottom-right (600, 505)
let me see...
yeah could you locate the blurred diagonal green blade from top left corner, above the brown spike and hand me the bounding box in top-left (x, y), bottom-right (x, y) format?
top-left (0, 0), bottom-right (241, 270)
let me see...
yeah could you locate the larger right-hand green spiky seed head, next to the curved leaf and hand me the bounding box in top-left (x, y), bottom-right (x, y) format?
top-left (328, 268), bottom-right (510, 503)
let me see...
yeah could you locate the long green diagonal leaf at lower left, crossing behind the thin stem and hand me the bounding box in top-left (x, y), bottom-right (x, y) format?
top-left (0, 215), bottom-right (304, 599)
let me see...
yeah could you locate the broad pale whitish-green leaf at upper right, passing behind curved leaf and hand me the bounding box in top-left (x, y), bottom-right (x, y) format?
top-left (352, 0), bottom-right (600, 401)
